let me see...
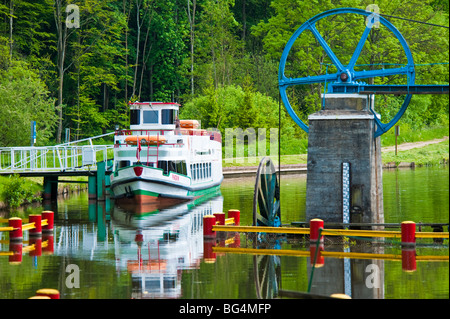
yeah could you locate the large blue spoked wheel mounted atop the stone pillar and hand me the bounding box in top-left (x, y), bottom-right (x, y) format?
top-left (278, 8), bottom-right (415, 137)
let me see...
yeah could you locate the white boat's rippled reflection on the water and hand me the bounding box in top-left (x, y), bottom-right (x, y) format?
top-left (111, 189), bottom-right (223, 299)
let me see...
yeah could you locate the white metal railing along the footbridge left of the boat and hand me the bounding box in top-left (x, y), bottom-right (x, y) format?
top-left (0, 144), bottom-right (114, 174)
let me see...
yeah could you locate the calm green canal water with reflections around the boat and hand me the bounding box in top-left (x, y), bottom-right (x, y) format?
top-left (0, 166), bottom-right (449, 299)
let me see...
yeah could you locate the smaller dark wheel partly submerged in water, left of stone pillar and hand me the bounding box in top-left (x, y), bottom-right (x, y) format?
top-left (253, 157), bottom-right (281, 227)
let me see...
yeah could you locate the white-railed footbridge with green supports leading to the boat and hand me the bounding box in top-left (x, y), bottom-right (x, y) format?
top-left (0, 132), bottom-right (114, 200)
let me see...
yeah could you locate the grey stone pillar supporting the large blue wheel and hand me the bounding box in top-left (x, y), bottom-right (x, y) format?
top-left (306, 94), bottom-right (384, 229)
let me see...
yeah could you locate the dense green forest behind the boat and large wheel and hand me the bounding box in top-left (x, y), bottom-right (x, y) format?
top-left (0, 0), bottom-right (449, 154)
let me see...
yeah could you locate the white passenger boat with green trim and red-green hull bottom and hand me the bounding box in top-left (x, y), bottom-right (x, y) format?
top-left (110, 102), bottom-right (223, 208)
